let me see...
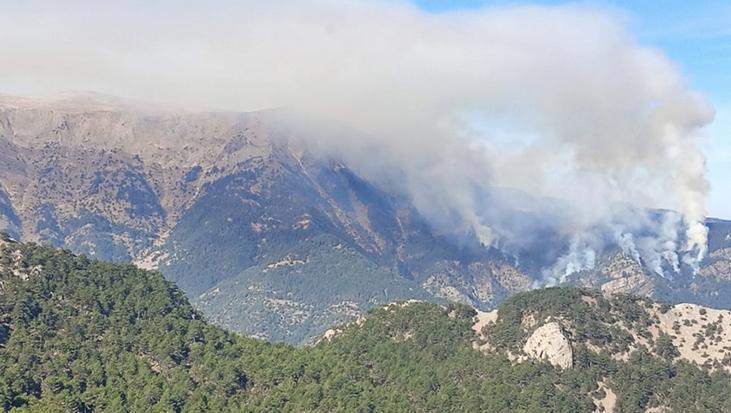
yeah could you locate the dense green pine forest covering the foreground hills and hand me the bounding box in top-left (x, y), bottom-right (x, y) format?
top-left (0, 243), bottom-right (731, 412)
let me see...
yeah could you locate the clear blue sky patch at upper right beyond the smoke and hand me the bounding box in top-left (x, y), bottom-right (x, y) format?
top-left (415, 0), bottom-right (731, 218)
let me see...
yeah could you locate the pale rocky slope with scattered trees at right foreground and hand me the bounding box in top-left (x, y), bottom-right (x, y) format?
top-left (473, 288), bottom-right (731, 371)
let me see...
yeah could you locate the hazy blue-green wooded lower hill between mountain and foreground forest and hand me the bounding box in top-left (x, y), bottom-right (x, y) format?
top-left (196, 236), bottom-right (434, 344)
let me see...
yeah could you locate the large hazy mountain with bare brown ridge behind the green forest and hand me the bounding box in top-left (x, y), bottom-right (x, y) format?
top-left (0, 95), bottom-right (731, 343)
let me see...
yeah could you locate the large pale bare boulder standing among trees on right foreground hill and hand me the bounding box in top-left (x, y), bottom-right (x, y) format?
top-left (523, 322), bottom-right (574, 369)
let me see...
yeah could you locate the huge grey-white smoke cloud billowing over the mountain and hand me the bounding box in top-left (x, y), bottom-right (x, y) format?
top-left (0, 0), bottom-right (713, 280)
